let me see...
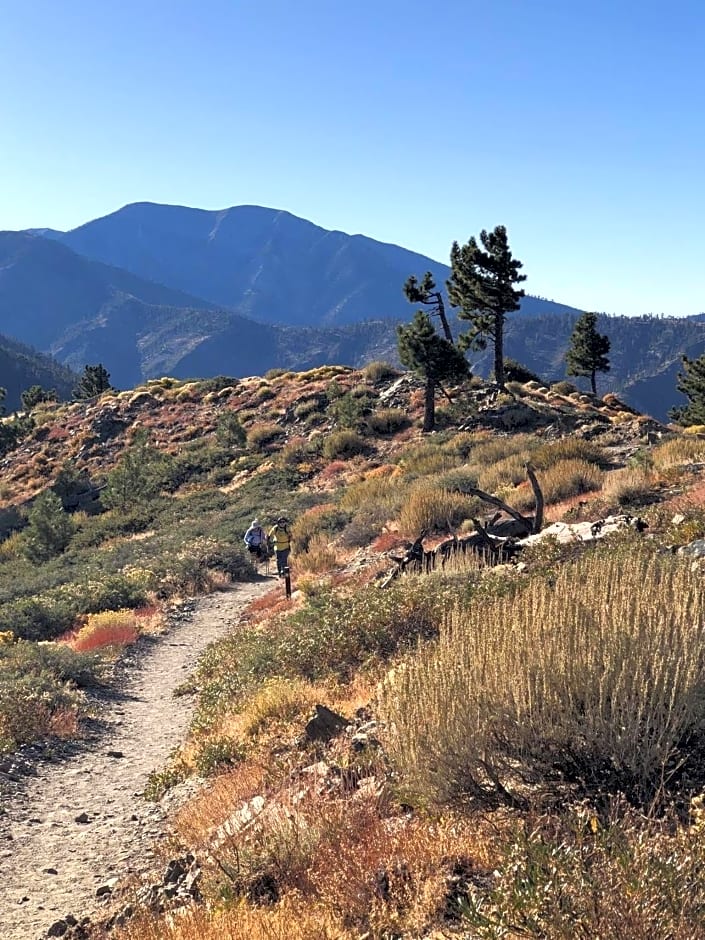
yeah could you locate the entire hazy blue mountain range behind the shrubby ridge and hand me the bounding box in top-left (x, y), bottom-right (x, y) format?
top-left (0, 203), bottom-right (705, 417)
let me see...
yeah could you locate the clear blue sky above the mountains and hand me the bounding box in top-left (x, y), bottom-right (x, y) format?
top-left (0, 0), bottom-right (705, 315)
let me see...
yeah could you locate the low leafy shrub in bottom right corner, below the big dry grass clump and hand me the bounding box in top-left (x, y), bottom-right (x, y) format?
top-left (460, 801), bottom-right (705, 940)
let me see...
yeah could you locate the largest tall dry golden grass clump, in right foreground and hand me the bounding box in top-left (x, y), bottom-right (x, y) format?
top-left (381, 548), bottom-right (705, 802)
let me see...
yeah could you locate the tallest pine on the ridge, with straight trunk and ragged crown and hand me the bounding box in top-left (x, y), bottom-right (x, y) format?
top-left (447, 225), bottom-right (526, 388)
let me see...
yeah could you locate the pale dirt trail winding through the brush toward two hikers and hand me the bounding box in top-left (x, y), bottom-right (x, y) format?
top-left (0, 581), bottom-right (272, 940)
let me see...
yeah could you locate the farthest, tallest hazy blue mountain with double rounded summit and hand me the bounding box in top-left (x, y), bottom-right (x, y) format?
top-left (53, 203), bottom-right (584, 326)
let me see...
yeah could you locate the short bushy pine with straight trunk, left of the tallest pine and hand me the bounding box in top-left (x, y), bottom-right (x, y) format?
top-left (397, 310), bottom-right (470, 431)
